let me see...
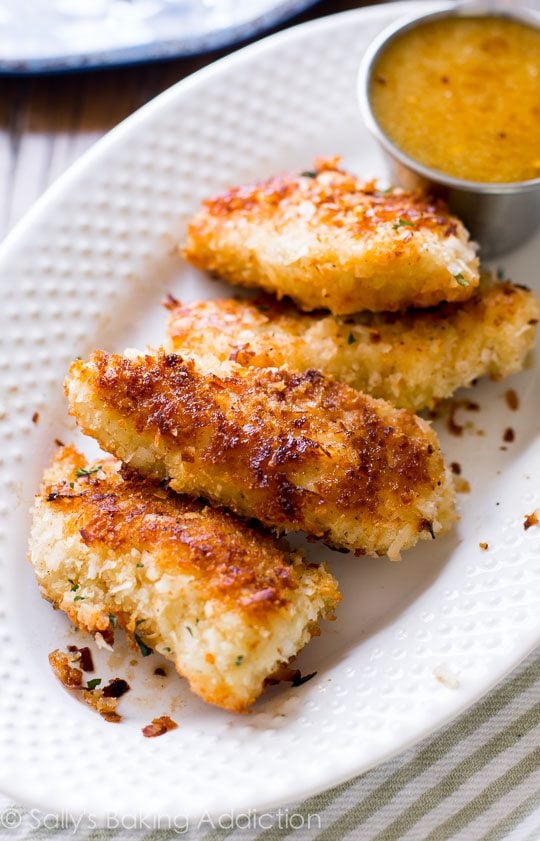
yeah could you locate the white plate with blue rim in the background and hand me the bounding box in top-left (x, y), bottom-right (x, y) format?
top-left (0, 0), bottom-right (316, 75)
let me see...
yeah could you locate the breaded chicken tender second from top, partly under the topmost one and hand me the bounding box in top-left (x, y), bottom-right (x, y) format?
top-left (168, 282), bottom-right (540, 411)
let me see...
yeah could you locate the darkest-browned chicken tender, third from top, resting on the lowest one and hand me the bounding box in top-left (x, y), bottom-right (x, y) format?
top-left (66, 351), bottom-right (454, 558)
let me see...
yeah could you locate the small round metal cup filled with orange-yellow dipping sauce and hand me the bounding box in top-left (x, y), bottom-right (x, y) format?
top-left (358, 4), bottom-right (540, 257)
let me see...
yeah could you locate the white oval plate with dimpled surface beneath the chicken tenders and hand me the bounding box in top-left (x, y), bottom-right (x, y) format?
top-left (0, 3), bottom-right (540, 816)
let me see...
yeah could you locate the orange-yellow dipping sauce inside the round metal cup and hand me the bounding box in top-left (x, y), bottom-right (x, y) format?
top-left (370, 16), bottom-right (540, 183)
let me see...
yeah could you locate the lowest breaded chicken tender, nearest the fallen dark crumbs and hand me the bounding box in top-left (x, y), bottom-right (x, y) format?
top-left (30, 447), bottom-right (340, 711)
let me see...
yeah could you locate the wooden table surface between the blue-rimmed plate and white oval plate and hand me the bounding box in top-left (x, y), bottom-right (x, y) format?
top-left (0, 0), bottom-right (382, 240)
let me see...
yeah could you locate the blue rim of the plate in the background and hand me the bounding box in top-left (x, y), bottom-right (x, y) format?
top-left (0, 0), bottom-right (318, 76)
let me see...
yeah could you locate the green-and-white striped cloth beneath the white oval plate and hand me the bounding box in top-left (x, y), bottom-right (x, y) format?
top-left (0, 652), bottom-right (540, 841)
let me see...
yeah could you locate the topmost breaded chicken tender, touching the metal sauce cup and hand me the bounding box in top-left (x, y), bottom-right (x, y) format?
top-left (183, 158), bottom-right (479, 315)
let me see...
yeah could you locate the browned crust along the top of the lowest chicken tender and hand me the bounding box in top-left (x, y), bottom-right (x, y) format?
top-left (41, 447), bottom-right (308, 618)
